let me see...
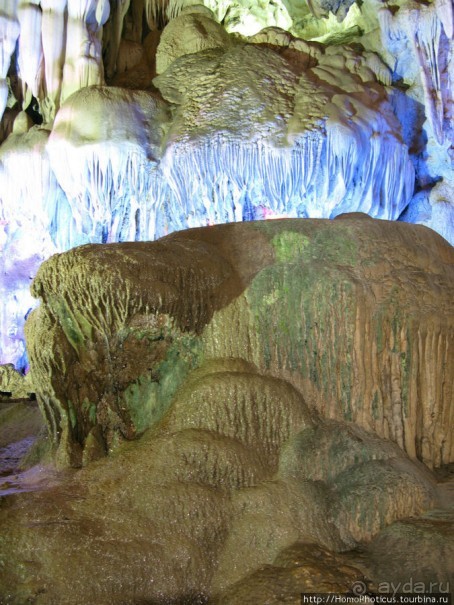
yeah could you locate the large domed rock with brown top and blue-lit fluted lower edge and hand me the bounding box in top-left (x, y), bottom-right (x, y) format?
top-left (154, 42), bottom-right (414, 226)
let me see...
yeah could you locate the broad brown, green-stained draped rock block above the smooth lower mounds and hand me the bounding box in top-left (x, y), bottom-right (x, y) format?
top-left (27, 215), bottom-right (454, 466)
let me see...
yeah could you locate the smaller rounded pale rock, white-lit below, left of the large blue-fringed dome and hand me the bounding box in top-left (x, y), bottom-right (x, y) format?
top-left (47, 87), bottom-right (168, 241)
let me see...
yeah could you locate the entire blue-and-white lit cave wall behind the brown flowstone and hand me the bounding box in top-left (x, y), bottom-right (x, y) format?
top-left (0, 0), bottom-right (454, 370)
